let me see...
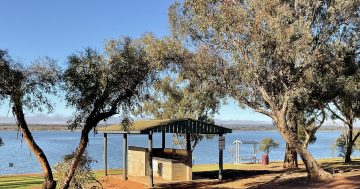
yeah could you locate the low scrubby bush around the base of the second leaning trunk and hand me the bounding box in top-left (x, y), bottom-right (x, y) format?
top-left (54, 152), bottom-right (98, 189)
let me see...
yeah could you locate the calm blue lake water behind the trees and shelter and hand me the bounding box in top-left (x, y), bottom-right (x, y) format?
top-left (0, 131), bottom-right (360, 174)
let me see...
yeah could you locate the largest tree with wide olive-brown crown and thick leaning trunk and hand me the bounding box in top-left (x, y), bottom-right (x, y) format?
top-left (169, 0), bottom-right (359, 180)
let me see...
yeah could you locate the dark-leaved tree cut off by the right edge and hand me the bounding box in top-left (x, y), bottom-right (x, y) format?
top-left (327, 5), bottom-right (360, 162)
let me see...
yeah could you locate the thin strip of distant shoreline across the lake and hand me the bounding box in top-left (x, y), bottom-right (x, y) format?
top-left (0, 124), bottom-right (342, 131)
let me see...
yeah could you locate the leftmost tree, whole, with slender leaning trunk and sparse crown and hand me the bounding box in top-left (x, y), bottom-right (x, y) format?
top-left (0, 50), bottom-right (60, 188)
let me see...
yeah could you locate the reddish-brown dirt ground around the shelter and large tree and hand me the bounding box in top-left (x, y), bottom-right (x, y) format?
top-left (100, 162), bottom-right (360, 189)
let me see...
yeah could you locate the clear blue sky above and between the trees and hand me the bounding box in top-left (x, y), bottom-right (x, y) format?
top-left (0, 0), bottom-right (270, 122)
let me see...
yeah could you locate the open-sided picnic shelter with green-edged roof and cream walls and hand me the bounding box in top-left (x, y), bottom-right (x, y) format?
top-left (104, 118), bottom-right (232, 187)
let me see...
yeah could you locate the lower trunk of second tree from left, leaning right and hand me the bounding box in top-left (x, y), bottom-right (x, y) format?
top-left (62, 125), bottom-right (92, 189)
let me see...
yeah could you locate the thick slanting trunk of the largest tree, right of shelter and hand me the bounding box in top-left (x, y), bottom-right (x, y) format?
top-left (276, 112), bottom-right (332, 181)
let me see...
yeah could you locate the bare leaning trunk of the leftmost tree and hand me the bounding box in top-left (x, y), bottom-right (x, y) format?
top-left (12, 96), bottom-right (56, 189)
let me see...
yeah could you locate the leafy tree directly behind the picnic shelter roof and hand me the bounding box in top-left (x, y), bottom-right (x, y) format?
top-left (137, 35), bottom-right (224, 151)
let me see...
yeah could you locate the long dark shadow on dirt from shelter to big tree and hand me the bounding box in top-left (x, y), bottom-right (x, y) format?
top-left (157, 169), bottom-right (284, 189)
